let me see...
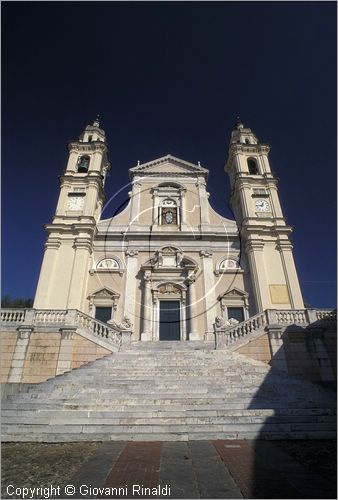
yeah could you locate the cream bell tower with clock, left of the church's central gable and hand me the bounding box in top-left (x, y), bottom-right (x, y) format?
top-left (34, 118), bottom-right (110, 311)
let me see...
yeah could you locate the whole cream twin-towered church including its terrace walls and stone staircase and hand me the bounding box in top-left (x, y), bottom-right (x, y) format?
top-left (0, 120), bottom-right (336, 442)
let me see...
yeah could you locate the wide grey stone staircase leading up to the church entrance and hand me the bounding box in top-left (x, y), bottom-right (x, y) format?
top-left (2, 341), bottom-right (336, 442)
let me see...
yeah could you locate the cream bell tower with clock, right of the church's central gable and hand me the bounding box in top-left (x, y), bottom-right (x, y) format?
top-left (225, 119), bottom-right (304, 313)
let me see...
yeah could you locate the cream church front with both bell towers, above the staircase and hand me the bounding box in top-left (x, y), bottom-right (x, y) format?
top-left (33, 120), bottom-right (304, 341)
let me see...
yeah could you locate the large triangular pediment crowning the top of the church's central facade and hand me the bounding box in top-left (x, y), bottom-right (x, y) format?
top-left (129, 155), bottom-right (209, 182)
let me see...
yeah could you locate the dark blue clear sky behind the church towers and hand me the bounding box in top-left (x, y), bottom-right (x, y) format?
top-left (2, 2), bottom-right (337, 307)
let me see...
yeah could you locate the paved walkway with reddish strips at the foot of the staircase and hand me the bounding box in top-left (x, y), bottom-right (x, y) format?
top-left (63, 440), bottom-right (336, 499)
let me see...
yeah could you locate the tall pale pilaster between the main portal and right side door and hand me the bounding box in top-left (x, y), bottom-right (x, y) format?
top-left (200, 250), bottom-right (217, 340)
